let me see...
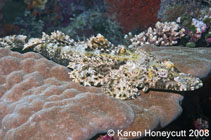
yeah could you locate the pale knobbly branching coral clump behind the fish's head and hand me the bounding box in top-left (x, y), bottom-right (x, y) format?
top-left (125, 22), bottom-right (185, 47)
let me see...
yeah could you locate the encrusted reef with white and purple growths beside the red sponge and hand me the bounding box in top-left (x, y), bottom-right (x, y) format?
top-left (160, 0), bottom-right (211, 47)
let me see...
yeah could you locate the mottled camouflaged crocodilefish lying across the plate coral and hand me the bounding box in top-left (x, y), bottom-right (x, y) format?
top-left (0, 31), bottom-right (203, 100)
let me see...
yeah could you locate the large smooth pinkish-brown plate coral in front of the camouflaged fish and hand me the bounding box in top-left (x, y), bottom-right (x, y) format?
top-left (0, 48), bottom-right (183, 140)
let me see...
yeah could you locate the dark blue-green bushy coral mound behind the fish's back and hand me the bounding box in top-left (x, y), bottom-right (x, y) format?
top-left (62, 7), bottom-right (123, 44)
